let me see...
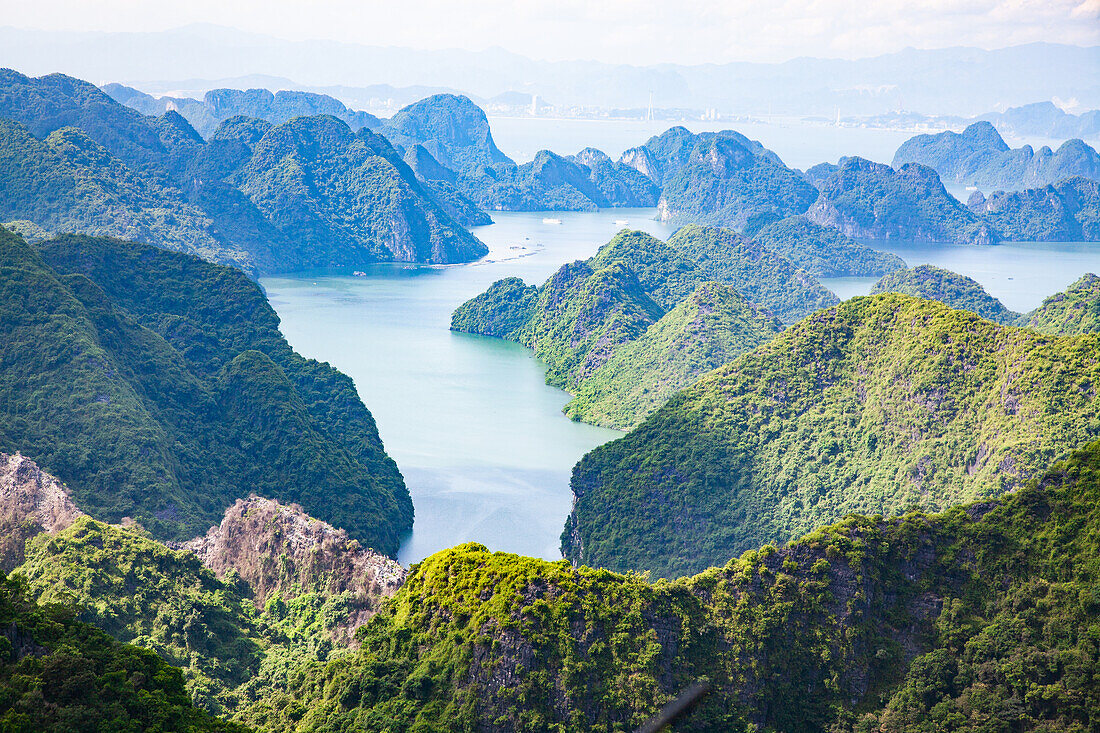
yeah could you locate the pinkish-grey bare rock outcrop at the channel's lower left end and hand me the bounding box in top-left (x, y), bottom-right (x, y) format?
top-left (178, 496), bottom-right (406, 638)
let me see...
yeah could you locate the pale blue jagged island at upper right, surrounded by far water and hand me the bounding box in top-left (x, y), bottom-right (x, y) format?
top-left (892, 122), bottom-right (1100, 190)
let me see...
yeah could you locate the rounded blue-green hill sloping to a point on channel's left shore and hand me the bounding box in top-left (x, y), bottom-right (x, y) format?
top-left (232, 117), bottom-right (488, 266)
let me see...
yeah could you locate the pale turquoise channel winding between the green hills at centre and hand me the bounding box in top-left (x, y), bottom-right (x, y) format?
top-left (263, 209), bottom-right (668, 565)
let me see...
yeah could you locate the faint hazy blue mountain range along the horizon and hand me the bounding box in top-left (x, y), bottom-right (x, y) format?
top-left (0, 25), bottom-right (1100, 118)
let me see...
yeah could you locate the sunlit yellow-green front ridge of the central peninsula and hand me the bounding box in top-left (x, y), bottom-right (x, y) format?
top-left (563, 282), bottom-right (783, 429)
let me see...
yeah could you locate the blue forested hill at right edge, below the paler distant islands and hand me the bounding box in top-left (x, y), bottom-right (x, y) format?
top-left (967, 177), bottom-right (1100, 242)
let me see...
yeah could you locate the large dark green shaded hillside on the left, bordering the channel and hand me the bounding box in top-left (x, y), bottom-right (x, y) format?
top-left (0, 231), bottom-right (413, 554)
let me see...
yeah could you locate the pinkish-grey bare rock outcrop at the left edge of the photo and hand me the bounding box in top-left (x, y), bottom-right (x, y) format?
top-left (0, 453), bottom-right (84, 572)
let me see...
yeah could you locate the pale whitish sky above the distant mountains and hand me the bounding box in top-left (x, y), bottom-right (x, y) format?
top-left (0, 0), bottom-right (1100, 64)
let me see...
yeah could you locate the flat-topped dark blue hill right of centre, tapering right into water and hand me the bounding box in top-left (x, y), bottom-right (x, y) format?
top-left (806, 157), bottom-right (998, 244)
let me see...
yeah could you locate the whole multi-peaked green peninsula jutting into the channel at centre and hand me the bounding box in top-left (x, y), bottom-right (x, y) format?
top-left (451, 226), bottom-right (837, 427)
